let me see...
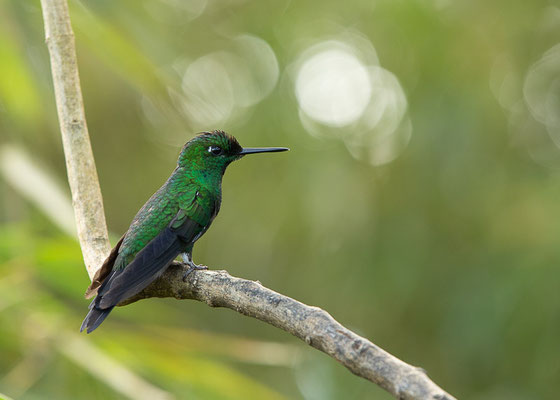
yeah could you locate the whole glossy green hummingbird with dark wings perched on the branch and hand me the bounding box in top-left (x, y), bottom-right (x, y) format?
top-left (80, 131), bottom-right (289, 333)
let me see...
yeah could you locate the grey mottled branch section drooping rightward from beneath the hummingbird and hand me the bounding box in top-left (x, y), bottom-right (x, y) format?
top-left (121, 263), bottom-right (453, 400)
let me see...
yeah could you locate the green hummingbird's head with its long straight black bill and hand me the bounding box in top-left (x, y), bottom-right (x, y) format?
top-left (177, 131), bottom-right (288, 174)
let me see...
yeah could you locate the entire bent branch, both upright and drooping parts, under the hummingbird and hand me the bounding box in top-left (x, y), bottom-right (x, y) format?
top-left (41, 0), bottom-right (454, 400)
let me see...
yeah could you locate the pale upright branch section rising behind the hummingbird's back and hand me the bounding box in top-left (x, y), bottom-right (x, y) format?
top-left (41, 0), bottom-right (111, 279)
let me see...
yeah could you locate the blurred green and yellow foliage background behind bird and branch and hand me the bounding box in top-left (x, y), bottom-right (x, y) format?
top-left (0, 0), bottom-right (560, 400)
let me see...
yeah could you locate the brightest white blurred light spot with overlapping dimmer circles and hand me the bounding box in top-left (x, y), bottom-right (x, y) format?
top-left (294, 34), bottom-right (412, 166)
